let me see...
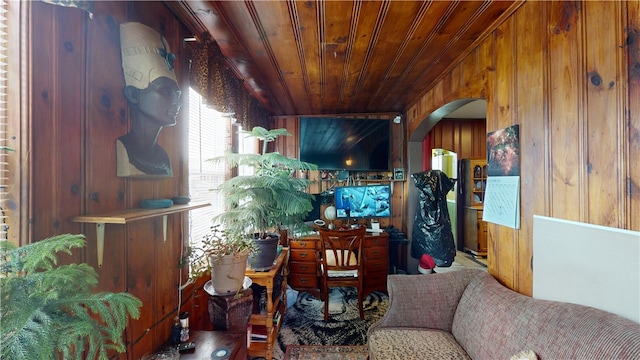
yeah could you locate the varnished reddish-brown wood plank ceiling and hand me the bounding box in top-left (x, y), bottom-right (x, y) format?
top-left (174, 0), bottom-right (519, 115)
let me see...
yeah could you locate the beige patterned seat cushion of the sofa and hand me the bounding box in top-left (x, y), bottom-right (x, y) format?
top-left (367, 328), bottom-right (471, 360)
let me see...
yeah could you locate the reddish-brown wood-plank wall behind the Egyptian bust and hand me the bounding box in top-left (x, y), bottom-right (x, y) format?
top-left (10, 1), bottom-right (198, 359)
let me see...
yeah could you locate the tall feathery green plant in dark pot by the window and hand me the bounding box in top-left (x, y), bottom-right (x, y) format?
top-left (210, 126), bottom-right (317, 271)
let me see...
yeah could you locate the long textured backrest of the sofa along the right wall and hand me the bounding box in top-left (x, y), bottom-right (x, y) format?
top-left (452, 275), bottom-right (640, 360)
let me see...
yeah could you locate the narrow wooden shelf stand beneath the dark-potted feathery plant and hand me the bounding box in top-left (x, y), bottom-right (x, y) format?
top-left (246, 247), bottom-right (289, 360)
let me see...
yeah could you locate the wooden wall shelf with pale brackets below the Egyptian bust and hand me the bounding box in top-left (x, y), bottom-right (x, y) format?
top-left (72, 203), bottom-right (211, 267)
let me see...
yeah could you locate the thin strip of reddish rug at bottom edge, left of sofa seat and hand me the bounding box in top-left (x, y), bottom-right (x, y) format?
top-left (284, 345), bottom-right (369, 360)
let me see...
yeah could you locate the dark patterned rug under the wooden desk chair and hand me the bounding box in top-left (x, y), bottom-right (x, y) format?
top-left (274, 288), bottom-right (389, 360)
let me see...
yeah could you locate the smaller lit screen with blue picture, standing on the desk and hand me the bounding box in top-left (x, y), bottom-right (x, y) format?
top-left (334, 184), bottom-right (391, 219)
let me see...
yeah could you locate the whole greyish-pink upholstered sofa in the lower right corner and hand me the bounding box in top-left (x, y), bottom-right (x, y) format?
top-left (367, 269), bottom-right (640, 360)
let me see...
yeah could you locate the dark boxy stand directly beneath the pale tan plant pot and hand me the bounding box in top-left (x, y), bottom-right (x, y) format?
top-left (209, 288), bottom-right (253, 332)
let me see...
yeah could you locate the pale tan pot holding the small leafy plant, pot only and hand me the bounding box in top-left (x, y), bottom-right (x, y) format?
top-left (209, 251), bottom-right (249, 294)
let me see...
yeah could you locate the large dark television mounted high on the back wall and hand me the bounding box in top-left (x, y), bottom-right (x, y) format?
top-left (299, 117), bottom-right (391, 171)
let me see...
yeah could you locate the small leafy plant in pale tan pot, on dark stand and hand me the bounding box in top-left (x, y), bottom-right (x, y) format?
top-left (181, 225), bottom-right (256, 294)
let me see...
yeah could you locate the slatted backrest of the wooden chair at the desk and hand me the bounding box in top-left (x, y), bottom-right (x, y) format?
top-left (318, 227), bottom-right (366, 271)
